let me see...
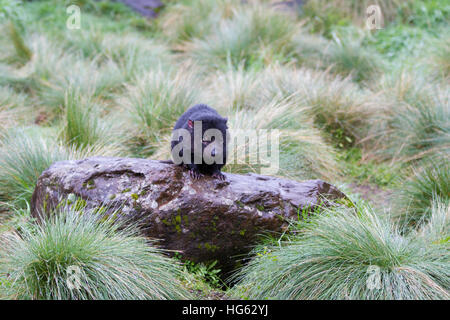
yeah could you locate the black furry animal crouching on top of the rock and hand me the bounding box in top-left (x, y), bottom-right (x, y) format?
top-left (171, 104), bottom-right (227, 180)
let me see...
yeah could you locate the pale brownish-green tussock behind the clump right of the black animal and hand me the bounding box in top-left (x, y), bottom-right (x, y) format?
top-left (263, 66), bottom-right (386, 148)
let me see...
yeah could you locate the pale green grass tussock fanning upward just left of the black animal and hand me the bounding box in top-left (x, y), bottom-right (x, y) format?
top-left (123, 68), bottom-right (199, 154)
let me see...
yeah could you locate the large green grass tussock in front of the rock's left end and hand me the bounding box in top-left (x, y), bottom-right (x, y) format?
top-left (0, 209), bottom-right (191, 300)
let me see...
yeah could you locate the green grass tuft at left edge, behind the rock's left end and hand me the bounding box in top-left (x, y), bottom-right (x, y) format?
top-left (0, 127), bottom-right (110, 207)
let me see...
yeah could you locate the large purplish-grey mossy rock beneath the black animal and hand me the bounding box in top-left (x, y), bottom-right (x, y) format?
top-left (32, 157), bottom-right (345, 269)
